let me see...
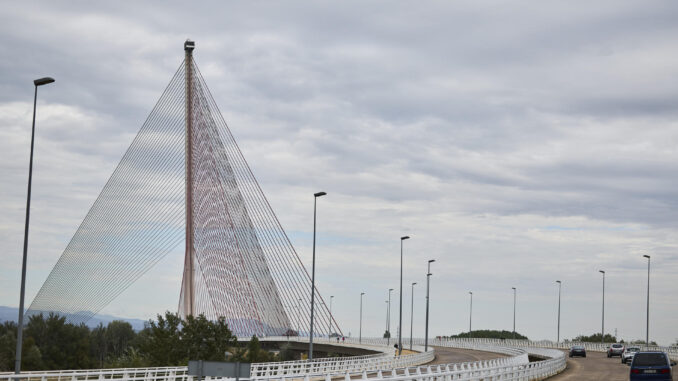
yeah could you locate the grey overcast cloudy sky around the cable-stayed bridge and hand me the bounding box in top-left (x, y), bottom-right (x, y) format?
top-left (0, 1), bottom-right (678, 344)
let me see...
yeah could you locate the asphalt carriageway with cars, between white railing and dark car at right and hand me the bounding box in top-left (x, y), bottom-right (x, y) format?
top-left (549, 352), bottom-right (629, 381)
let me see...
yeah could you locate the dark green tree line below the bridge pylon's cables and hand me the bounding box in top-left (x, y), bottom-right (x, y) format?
top-left (0, 312), bottom-right (282, 371)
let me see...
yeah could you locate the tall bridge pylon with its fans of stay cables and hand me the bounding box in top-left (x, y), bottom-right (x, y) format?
top-left (28, 41), bottom-right (341, 336)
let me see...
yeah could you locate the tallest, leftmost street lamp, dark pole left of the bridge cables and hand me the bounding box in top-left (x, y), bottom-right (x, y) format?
top-left (14, 77), bottom-right (54, 374)
